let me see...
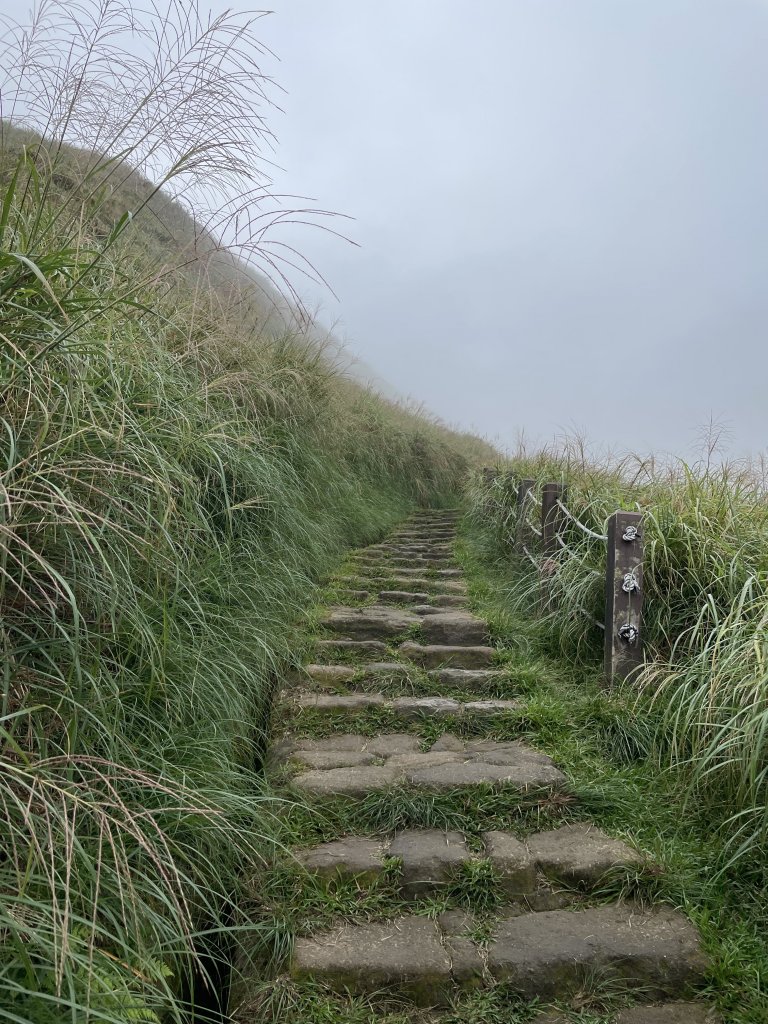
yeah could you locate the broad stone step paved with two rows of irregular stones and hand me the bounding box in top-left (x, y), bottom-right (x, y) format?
top-left (286, 733), bottom-right (565, 798)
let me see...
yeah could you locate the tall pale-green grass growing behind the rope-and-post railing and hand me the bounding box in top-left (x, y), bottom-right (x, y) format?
top-left (472, 442), bottom-right (768, 872)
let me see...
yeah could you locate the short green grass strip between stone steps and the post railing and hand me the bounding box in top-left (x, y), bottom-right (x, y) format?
top-left (460, 528), bottom-right (768, 1024)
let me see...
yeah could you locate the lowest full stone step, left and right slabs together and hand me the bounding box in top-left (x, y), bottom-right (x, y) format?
top-left (291, 904), bottom-right (707, 1003)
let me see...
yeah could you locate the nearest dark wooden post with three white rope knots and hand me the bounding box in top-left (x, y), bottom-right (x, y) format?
top-left (605, 512), bottom-right (643, 686)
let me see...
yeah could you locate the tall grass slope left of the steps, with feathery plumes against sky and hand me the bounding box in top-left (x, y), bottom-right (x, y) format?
top-left (0, 0), bottom-right (487, 1024)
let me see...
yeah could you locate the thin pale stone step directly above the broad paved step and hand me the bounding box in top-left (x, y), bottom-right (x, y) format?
top-left (286, 688), bottom-right (522, 722)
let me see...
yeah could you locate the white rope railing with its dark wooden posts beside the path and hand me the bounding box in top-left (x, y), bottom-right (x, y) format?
top-left (495, 479), bottom-right (643, 682)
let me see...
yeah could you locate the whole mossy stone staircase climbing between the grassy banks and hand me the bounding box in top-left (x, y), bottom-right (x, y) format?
top-left (241, 511), bottom-right (715, 1024)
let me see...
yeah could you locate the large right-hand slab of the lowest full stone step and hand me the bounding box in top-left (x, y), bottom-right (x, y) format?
top-left (487, 904), bottom-right (707, 998)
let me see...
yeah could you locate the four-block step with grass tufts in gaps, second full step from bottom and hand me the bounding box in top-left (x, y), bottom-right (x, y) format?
top-left (296, 819), bottom-right (644, 892)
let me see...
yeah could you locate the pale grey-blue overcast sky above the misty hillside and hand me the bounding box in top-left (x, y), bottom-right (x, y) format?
top-left (243, 0), bottom-right (768, 453)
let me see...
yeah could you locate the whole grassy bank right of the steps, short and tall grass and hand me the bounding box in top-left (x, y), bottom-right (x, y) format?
top-left (465, 452), bottom-right (768, 1024)
